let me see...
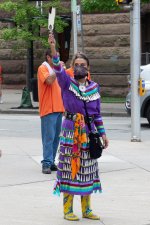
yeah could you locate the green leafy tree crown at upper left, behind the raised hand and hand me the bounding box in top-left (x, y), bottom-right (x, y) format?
top-left (0, 0), bottom-right (67, 46)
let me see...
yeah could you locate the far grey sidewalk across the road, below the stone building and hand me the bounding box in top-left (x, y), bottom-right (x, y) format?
top-left (0, 89), bottom-right (127, 117)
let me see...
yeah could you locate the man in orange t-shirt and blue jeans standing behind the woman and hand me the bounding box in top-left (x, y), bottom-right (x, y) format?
top-left (38, 49), bottom-right (64, 174)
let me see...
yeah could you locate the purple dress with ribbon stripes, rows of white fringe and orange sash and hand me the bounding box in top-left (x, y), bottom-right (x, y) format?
top-left (53, 56), bottom-right (105, 195)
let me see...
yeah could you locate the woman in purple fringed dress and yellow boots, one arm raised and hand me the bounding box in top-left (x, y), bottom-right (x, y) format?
top-left (48, 34), bottom-right (108, 221)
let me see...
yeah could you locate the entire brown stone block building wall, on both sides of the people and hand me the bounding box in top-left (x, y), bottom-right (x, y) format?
top-left (0, 9), bottom-right (130, 96)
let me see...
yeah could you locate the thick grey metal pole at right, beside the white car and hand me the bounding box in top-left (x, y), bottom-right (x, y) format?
top-left (131, 0), bottom-right (141, 142)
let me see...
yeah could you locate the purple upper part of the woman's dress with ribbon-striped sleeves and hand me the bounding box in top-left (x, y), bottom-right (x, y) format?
top-left (53, 56), bottom-right (105, 135)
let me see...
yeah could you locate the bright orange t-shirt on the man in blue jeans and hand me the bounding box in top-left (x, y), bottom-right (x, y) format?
top-left (38, 62), bottom-right (64, 117)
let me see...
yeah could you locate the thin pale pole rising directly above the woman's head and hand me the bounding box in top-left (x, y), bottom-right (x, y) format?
top-left (71, 0), bottom-right (78, 54)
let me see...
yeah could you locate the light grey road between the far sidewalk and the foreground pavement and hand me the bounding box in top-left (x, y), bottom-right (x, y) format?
top-left (0, 114), bottom-right (150, 140)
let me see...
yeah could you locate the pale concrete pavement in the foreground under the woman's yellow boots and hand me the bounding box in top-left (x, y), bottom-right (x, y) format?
top-left (0, 133), bottom-right (150, 225)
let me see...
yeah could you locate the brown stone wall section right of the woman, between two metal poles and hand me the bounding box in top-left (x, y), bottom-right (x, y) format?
top-left (79, 13), bottom-right (130, 96)
